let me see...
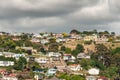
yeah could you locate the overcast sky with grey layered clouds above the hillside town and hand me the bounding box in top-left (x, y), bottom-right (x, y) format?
top-left (0, 0), bottom-right (120, 33)
